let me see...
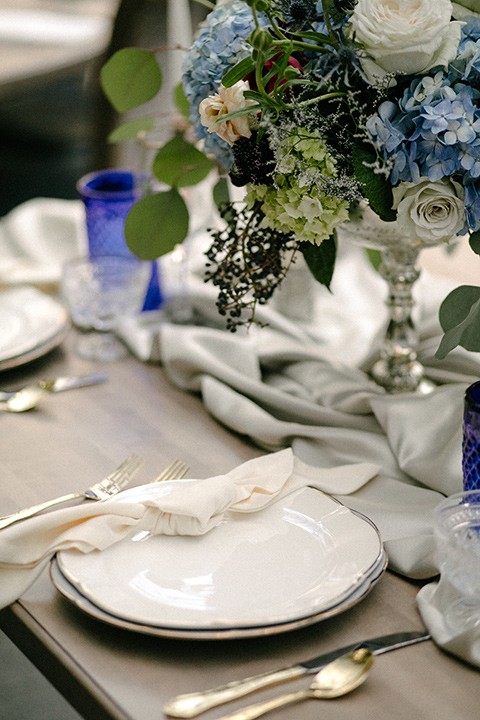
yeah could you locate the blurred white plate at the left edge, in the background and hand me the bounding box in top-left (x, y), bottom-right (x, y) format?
top-left (0, 286), bottom-right (70, 370)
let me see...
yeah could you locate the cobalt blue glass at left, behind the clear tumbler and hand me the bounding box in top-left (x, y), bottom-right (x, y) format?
top-left (77, 169), bottom-right (163, 310)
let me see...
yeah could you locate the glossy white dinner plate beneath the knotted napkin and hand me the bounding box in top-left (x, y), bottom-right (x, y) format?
top-left (58, 481), bottom-right (385, 637)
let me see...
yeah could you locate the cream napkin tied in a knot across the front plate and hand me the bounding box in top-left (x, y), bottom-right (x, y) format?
top-left (0, 449), bottom-right (379, 608)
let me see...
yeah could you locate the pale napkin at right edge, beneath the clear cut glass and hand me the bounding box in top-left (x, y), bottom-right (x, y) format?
top-left (417, 577), bottom-right (480, 667)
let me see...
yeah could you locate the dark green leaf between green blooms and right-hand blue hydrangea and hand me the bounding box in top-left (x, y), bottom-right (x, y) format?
top-left (352, 143), bottom-right (397, 222)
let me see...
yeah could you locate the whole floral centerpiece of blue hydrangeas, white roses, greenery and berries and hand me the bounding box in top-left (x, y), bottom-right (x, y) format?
top-left (102, 0), bottom-right (480, 368)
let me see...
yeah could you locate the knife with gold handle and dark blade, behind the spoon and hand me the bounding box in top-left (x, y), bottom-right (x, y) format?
top-left (163, 630), bottom-right (431, 718)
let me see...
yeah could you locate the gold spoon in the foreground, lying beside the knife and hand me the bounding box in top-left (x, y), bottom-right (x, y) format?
top-left (214, 648), bottom-right (373, 720)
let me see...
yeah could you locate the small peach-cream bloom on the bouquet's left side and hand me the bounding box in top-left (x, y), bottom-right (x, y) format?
top-left (199, 80), bottom-right (257, 145)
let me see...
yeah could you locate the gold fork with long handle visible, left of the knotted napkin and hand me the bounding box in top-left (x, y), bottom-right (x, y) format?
top-left (0, 453), bottom-right (145, 530)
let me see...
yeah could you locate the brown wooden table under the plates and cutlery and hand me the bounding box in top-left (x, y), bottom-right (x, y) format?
top-left (0, 334), bottom-right (479, 720)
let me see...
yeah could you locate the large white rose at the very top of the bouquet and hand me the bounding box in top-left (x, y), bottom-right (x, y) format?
top-left (350, 0), bottom-right (464, 80)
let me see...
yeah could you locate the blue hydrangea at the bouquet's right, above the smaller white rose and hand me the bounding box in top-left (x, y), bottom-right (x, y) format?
top-left (367, 33), bottom-right (480, 229)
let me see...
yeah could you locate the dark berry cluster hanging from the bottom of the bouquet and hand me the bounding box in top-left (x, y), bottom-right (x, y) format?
top-left (205, 203), bottom-right (297, 332)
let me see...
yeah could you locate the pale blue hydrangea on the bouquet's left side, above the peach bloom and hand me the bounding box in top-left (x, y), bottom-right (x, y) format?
top-left (183, 0), bottom-right (260, 170)
